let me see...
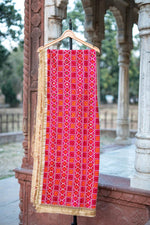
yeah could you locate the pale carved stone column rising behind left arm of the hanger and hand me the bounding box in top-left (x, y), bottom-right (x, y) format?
top-left (44, 0), bottom-right (68, 49)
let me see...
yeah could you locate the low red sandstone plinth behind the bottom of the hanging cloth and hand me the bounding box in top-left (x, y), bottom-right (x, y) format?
top-left (16, 169), bottom-right (150, 225)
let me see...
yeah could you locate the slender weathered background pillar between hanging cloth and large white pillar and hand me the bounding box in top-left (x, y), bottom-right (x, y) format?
top-left (116, 44), bottom-right (131, 145)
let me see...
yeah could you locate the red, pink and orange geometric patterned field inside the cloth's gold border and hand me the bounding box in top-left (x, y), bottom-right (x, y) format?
top-left (42, 50), bottom-right (100, 208)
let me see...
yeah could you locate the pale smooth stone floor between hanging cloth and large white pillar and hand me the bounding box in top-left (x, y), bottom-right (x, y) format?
top-left (100, 144), bottom-right (135, 178)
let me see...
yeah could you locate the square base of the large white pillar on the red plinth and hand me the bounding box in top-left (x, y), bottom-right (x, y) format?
top-left (130, 172), bottom-right (150, 191)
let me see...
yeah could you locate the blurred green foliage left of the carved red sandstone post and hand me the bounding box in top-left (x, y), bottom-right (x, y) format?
top-left (0, 0), bottom-right (23, 107)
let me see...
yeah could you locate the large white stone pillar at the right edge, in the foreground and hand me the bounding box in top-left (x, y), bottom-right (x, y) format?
top-left (131, 0), bottom-right (150, 190)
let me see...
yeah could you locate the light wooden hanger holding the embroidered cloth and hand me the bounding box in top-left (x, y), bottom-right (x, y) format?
top-left (37, 30), bottom-right (100, 53)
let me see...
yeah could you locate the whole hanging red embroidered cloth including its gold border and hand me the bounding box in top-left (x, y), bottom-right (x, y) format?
top-left (31, 49), bottom-right (100, 217)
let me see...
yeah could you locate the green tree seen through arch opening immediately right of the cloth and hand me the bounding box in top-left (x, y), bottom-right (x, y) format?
top-left (100, 11), bottom-right (119, 102)
